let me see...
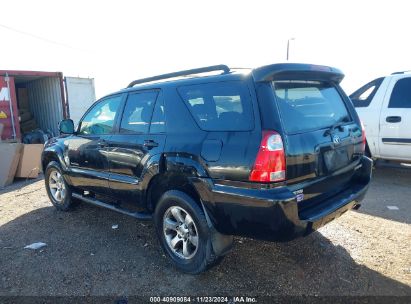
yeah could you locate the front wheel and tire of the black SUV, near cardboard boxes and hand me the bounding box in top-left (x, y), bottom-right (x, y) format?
top-left (44, 161), bottom-right (74, 211)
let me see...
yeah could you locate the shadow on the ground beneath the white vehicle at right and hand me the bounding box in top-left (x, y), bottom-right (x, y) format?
top-left (358, 161), bottom-right (411, 224)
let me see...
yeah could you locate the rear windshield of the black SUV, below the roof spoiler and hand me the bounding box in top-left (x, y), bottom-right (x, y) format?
top-left (273, 80), bottom-right (351, 133)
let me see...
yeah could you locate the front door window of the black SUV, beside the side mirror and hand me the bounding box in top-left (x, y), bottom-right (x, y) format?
top-left (79, 95), bottom-right (121, 135)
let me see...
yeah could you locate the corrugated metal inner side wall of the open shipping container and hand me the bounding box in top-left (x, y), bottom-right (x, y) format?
top-left (27, 77), bottom-right (63, 136)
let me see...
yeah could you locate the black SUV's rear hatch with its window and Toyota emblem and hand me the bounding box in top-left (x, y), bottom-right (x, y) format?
top-left (272, 78), bottom-right (362, 213)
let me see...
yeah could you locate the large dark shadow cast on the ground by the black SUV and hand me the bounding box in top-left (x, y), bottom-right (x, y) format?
top-left (0, 204), bottom-right (411, 296)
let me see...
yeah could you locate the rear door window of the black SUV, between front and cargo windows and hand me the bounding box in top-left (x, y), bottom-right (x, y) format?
top-left (120, 92), bottom-right (158, 133)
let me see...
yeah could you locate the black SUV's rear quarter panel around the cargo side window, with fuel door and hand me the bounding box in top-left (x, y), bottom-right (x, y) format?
top-left (164, 77), bottom-right (261, 181)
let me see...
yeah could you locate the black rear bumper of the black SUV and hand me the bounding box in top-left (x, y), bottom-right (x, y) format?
top-left (194, 157), bottom-right (372, 241)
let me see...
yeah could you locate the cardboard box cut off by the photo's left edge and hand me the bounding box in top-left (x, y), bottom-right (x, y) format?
top-left (0, 143), bottom-right (23, 187)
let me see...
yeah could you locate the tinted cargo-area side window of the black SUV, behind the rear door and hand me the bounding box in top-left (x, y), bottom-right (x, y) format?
top-left (178, 81), bottom-right (254, 131)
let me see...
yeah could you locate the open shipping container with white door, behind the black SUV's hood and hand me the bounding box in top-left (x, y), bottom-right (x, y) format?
top-left (0, 70), bottom-right (95, 141)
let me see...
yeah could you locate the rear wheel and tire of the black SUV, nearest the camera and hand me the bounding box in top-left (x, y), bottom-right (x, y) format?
top-left (154, 190), bottom-right (222, 274)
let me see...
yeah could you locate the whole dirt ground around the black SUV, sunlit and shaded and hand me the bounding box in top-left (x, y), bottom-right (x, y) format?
top-left (0, 165), bottom-right (411, 296)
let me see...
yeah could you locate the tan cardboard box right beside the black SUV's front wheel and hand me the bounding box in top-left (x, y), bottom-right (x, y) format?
top-left (15, 144), bottom-right (43, 178)
